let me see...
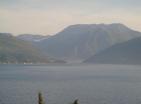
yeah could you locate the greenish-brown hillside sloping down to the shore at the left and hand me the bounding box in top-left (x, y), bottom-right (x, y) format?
top-left (0, 33), bottom-right (49, 63)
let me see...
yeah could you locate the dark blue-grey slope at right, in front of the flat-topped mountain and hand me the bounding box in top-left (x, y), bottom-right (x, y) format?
top-left (84, 37), bottom-right (141, 65)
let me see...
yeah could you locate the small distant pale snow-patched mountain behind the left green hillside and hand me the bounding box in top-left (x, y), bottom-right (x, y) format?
top-left (17, 34), bottom-right (50, 42)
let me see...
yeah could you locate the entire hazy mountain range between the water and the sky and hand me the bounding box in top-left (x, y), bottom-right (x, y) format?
top-left (0, 23), bottom-right (141, 64)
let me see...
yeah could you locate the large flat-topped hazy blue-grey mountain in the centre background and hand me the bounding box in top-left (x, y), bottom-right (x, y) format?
top-left (38, 23), bottom-right (141, 61)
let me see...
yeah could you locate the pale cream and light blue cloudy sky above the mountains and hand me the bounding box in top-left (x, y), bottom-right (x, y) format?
top-left (0, 0), bottom-right (141, 35)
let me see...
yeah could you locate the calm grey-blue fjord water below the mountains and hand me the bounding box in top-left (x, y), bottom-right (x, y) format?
top-left (0, 65), bottom-right (141, 104)
